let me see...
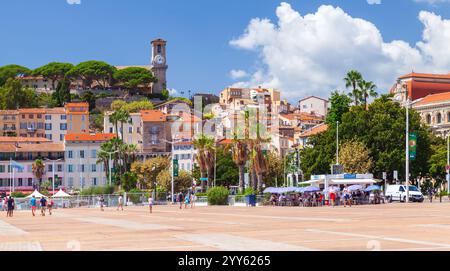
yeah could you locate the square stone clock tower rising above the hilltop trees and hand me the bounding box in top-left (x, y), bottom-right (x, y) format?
top-left (151, 39), bottom-right (168, 94)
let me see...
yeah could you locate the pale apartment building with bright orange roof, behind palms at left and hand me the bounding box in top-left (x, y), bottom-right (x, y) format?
top-left (64, 134), bottom-right (116, 189)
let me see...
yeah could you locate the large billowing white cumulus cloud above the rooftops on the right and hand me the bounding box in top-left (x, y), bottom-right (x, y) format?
top-left (230, 3), bottom-right (450, 100)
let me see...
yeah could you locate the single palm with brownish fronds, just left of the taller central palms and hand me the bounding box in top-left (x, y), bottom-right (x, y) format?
top-left (193, 134), bottom-right (215, 189)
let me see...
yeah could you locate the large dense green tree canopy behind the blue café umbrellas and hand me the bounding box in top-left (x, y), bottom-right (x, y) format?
top-left (302, 95), bottom-right (434, 183)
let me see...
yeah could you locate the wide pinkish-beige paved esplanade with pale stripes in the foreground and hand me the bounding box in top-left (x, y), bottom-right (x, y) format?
top-left (0, 203), bottom-right (450, 251)
